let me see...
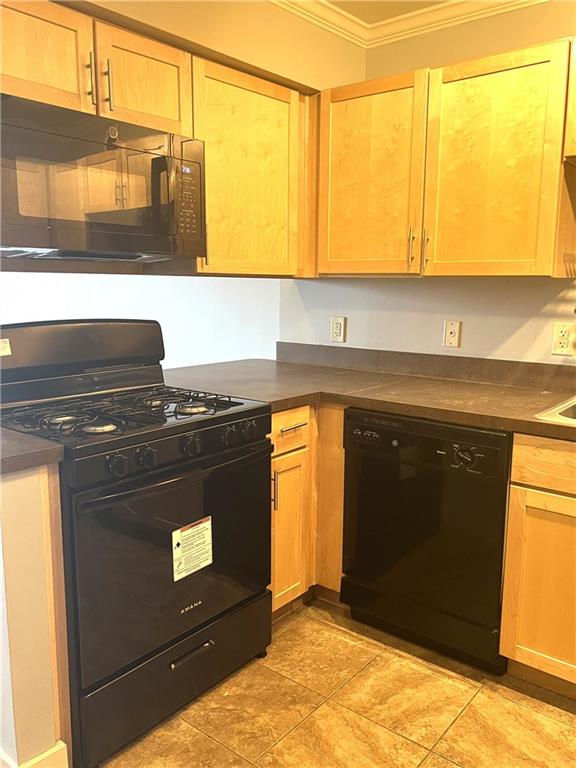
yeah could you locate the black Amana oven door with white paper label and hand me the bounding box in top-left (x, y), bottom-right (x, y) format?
top-left (72, 441), bottom-right (271, 690)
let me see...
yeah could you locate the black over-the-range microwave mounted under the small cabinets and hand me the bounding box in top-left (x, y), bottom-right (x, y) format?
top-left (0, 95), bottom-right (206, 274)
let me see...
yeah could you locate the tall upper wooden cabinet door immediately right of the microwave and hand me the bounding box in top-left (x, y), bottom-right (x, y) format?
top-left (194, 58), bottom-right (299, 275)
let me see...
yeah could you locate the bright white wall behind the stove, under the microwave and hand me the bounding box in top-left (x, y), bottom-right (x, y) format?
top-left (0, 272), bottom-right (279, 368)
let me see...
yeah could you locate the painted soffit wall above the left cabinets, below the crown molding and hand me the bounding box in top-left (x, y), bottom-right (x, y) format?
top-left (93, 0), bottom-right (366, 89)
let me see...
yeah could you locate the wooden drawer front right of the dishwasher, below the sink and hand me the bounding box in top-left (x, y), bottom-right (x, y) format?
top-left (512, 435), bottom-right (576, 496)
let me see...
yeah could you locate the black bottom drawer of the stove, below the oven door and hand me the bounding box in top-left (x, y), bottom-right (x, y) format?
top-left (80, 591), bottom-right (271, 768)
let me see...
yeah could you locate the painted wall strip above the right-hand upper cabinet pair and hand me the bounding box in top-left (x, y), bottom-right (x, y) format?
top-left (366, 0), bottom-right (576, 78)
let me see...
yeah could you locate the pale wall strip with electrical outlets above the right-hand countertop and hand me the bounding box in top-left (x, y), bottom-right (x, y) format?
top-left (280, 278), bottom-right (576, 364)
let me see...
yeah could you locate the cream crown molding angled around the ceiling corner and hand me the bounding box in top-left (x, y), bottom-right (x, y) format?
top-left (268, 0), bottom-right (550, 48)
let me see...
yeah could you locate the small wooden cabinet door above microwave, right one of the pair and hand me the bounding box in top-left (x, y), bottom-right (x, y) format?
top-left (95, 21), bottom-right (192, 136)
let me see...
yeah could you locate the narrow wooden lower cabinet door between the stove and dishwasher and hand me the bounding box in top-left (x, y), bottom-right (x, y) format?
top-left (271, 448), bottom-right (311, 611)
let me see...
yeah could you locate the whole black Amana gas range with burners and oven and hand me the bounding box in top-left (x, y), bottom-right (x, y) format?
top-left (0, 320), bottom-right (272, 768)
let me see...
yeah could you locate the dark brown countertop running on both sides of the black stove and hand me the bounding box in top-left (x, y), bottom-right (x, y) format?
top-left (0, 360), bottom-right (576, 473)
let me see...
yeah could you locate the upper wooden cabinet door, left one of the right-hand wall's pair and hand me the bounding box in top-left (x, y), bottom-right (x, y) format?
top-left (318, 70), bottom-right (428, 274)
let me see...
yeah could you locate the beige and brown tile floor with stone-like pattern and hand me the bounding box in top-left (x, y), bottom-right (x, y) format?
top-left (105, 602), bottom-right (576, 768)
